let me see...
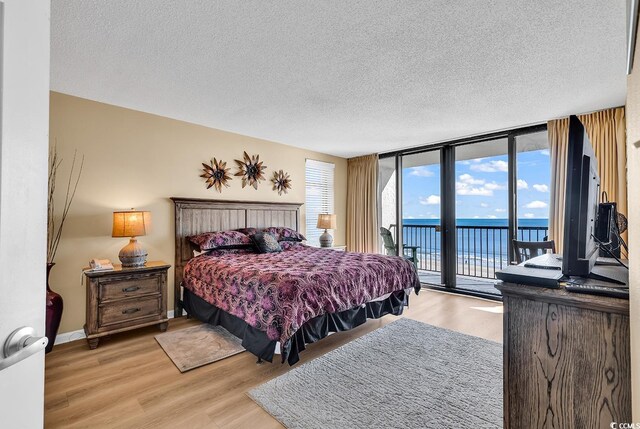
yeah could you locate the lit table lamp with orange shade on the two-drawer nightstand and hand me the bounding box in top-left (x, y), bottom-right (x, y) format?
top-left (111, 209), bottom-right (151, 267)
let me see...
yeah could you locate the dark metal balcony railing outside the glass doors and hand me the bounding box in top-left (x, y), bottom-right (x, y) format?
top-left (392, 225), bottom-right (549, 279)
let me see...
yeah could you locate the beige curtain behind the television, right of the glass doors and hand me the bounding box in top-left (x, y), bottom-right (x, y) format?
top-left (548, 107), bottom-right (627, 252)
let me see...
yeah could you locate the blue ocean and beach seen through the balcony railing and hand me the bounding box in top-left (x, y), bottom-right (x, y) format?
top-left (403, 219), bottom-right (549, 277)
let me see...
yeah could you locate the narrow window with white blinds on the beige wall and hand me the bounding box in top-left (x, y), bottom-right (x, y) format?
top-left (305, 159), bottom-right (335, 246)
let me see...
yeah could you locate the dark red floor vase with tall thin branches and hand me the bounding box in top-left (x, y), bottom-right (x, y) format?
top-left (45, 146), bottom-right (84, 353)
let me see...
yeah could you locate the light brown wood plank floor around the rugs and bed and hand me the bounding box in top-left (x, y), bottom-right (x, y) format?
top-left (45, 290), bottom-right (502, 429)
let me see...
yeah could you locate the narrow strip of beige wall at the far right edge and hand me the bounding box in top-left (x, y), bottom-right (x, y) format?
top-left (626, 37), bottom-right (640, 421)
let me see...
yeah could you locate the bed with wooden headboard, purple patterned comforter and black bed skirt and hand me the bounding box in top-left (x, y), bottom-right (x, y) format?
top-left (172, 198), bottom-right (420, 365)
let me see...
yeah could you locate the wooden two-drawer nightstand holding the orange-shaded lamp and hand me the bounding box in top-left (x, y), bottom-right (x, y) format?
top-left (84, 261), bottom-right (171, 350)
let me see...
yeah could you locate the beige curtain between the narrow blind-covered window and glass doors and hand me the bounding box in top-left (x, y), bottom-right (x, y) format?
top-left (347, 155), bottom-right (379, 253)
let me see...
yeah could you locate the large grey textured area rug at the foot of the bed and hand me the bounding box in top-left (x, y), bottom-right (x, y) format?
top-left (248, 318), bottom-right (502, 429)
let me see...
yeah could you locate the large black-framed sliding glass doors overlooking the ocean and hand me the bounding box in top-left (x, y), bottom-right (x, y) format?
top-left (379, 124), bottom-right (550, 296)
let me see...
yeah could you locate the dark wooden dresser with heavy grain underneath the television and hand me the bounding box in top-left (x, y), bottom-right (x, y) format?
top-left (496, 283), bottom-right (631, 429)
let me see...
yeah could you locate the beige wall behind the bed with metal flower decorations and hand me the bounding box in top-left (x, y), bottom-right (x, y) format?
top-left (50, 92), bottom-right (347, 332)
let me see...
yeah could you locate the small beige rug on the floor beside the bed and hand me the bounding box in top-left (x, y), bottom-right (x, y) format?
top-left (156, 323), bottom-right (244, 372)
